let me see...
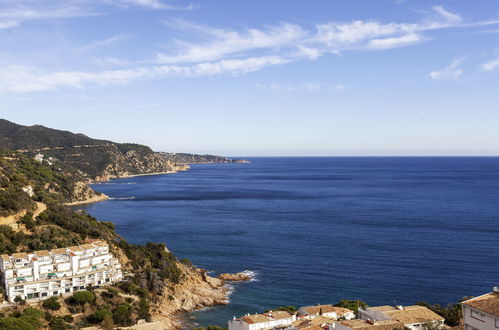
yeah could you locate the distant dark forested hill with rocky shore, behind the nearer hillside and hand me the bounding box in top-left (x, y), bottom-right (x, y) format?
top-left (0, 119), bottom-right (182, 180)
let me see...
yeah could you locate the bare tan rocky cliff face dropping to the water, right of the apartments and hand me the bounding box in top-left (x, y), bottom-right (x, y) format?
top-left (151, 263), bottom-right (229, 329)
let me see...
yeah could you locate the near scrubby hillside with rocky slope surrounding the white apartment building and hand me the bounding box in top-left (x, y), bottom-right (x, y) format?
top-left (0, 149), bottom-right (227, 329)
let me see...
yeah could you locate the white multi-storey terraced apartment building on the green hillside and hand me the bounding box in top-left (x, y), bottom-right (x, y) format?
top-left (0, 240), bottom-right (123, 302)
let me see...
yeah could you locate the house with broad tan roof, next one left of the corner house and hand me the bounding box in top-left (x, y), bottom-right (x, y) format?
top-left (358, 305), bottom-right (445, 330)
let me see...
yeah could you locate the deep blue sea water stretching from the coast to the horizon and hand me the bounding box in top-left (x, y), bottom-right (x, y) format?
top-left (80, 157), bottom-right (499, 325)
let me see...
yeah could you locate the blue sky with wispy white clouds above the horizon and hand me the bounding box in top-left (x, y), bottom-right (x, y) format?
top-left (0, 0), bottom-right (499, 156)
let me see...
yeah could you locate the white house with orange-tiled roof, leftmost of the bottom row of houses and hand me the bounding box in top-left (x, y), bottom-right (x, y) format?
top-left (228, 311), bottom-right (296, 330)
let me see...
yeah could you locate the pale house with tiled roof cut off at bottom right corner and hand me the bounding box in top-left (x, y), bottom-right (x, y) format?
top-left (461, 287), bottom-right (499, 330)
